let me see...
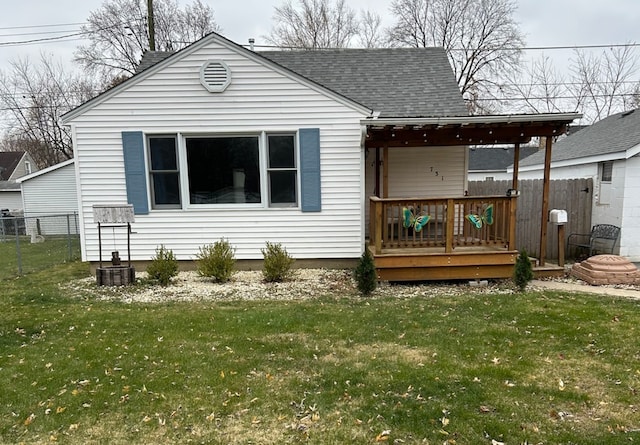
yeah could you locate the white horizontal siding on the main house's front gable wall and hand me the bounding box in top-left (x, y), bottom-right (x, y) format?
top-left (72, 40), bottom-right (363, 261)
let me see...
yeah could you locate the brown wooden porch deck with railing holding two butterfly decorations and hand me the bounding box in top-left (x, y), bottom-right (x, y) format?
top-left (368, 196), bottom-right (563, 281)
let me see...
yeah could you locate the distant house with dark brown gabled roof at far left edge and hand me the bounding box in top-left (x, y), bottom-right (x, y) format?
top-left (0, 151), bottom-right (37, 213)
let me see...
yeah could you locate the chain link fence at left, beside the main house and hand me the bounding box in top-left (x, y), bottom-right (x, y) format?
top-left (0, 212), bottom-right (81, 279)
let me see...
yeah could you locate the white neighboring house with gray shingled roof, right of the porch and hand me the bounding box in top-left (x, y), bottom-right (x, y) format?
top-left (519, 109), bottom-right (640, 262)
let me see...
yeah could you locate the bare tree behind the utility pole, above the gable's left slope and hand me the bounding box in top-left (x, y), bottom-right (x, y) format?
top-left (75, 0), bottom-right (219, 82)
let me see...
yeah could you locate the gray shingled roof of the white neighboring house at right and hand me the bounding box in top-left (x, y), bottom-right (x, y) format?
top-left (520, 109), bottom-right (640, 166)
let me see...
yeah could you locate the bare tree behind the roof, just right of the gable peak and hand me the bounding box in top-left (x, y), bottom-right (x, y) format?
top-left (265, 0), bottom-right (359, 49)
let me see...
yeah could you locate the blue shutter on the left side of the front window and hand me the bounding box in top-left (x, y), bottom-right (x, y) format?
top-left (122, 131), bottom-right (149, 215)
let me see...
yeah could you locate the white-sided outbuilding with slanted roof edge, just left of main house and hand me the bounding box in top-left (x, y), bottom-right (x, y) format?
top-left (17, 159), bottom-right (78, 235)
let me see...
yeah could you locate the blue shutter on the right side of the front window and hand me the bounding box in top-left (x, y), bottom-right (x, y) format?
top-left (299, 128), bottom-right (322, 212)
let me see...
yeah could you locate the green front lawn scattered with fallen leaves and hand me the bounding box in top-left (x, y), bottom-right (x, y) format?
top-left (0, 263), bottom-right (640, 444)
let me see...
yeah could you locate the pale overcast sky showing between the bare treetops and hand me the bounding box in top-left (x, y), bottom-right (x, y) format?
top-left (0, 0), bottom-right (640, 69)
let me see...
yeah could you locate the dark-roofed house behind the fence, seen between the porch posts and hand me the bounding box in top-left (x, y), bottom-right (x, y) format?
top-left (468, 145), bottom-right (540, 181)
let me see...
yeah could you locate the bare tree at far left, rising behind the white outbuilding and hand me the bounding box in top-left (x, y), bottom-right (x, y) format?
top-left (0, 55), bottom-right (97, 168)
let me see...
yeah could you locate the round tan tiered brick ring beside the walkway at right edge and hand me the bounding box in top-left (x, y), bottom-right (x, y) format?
top-left (571, 255), bottom-right (640, 286)
